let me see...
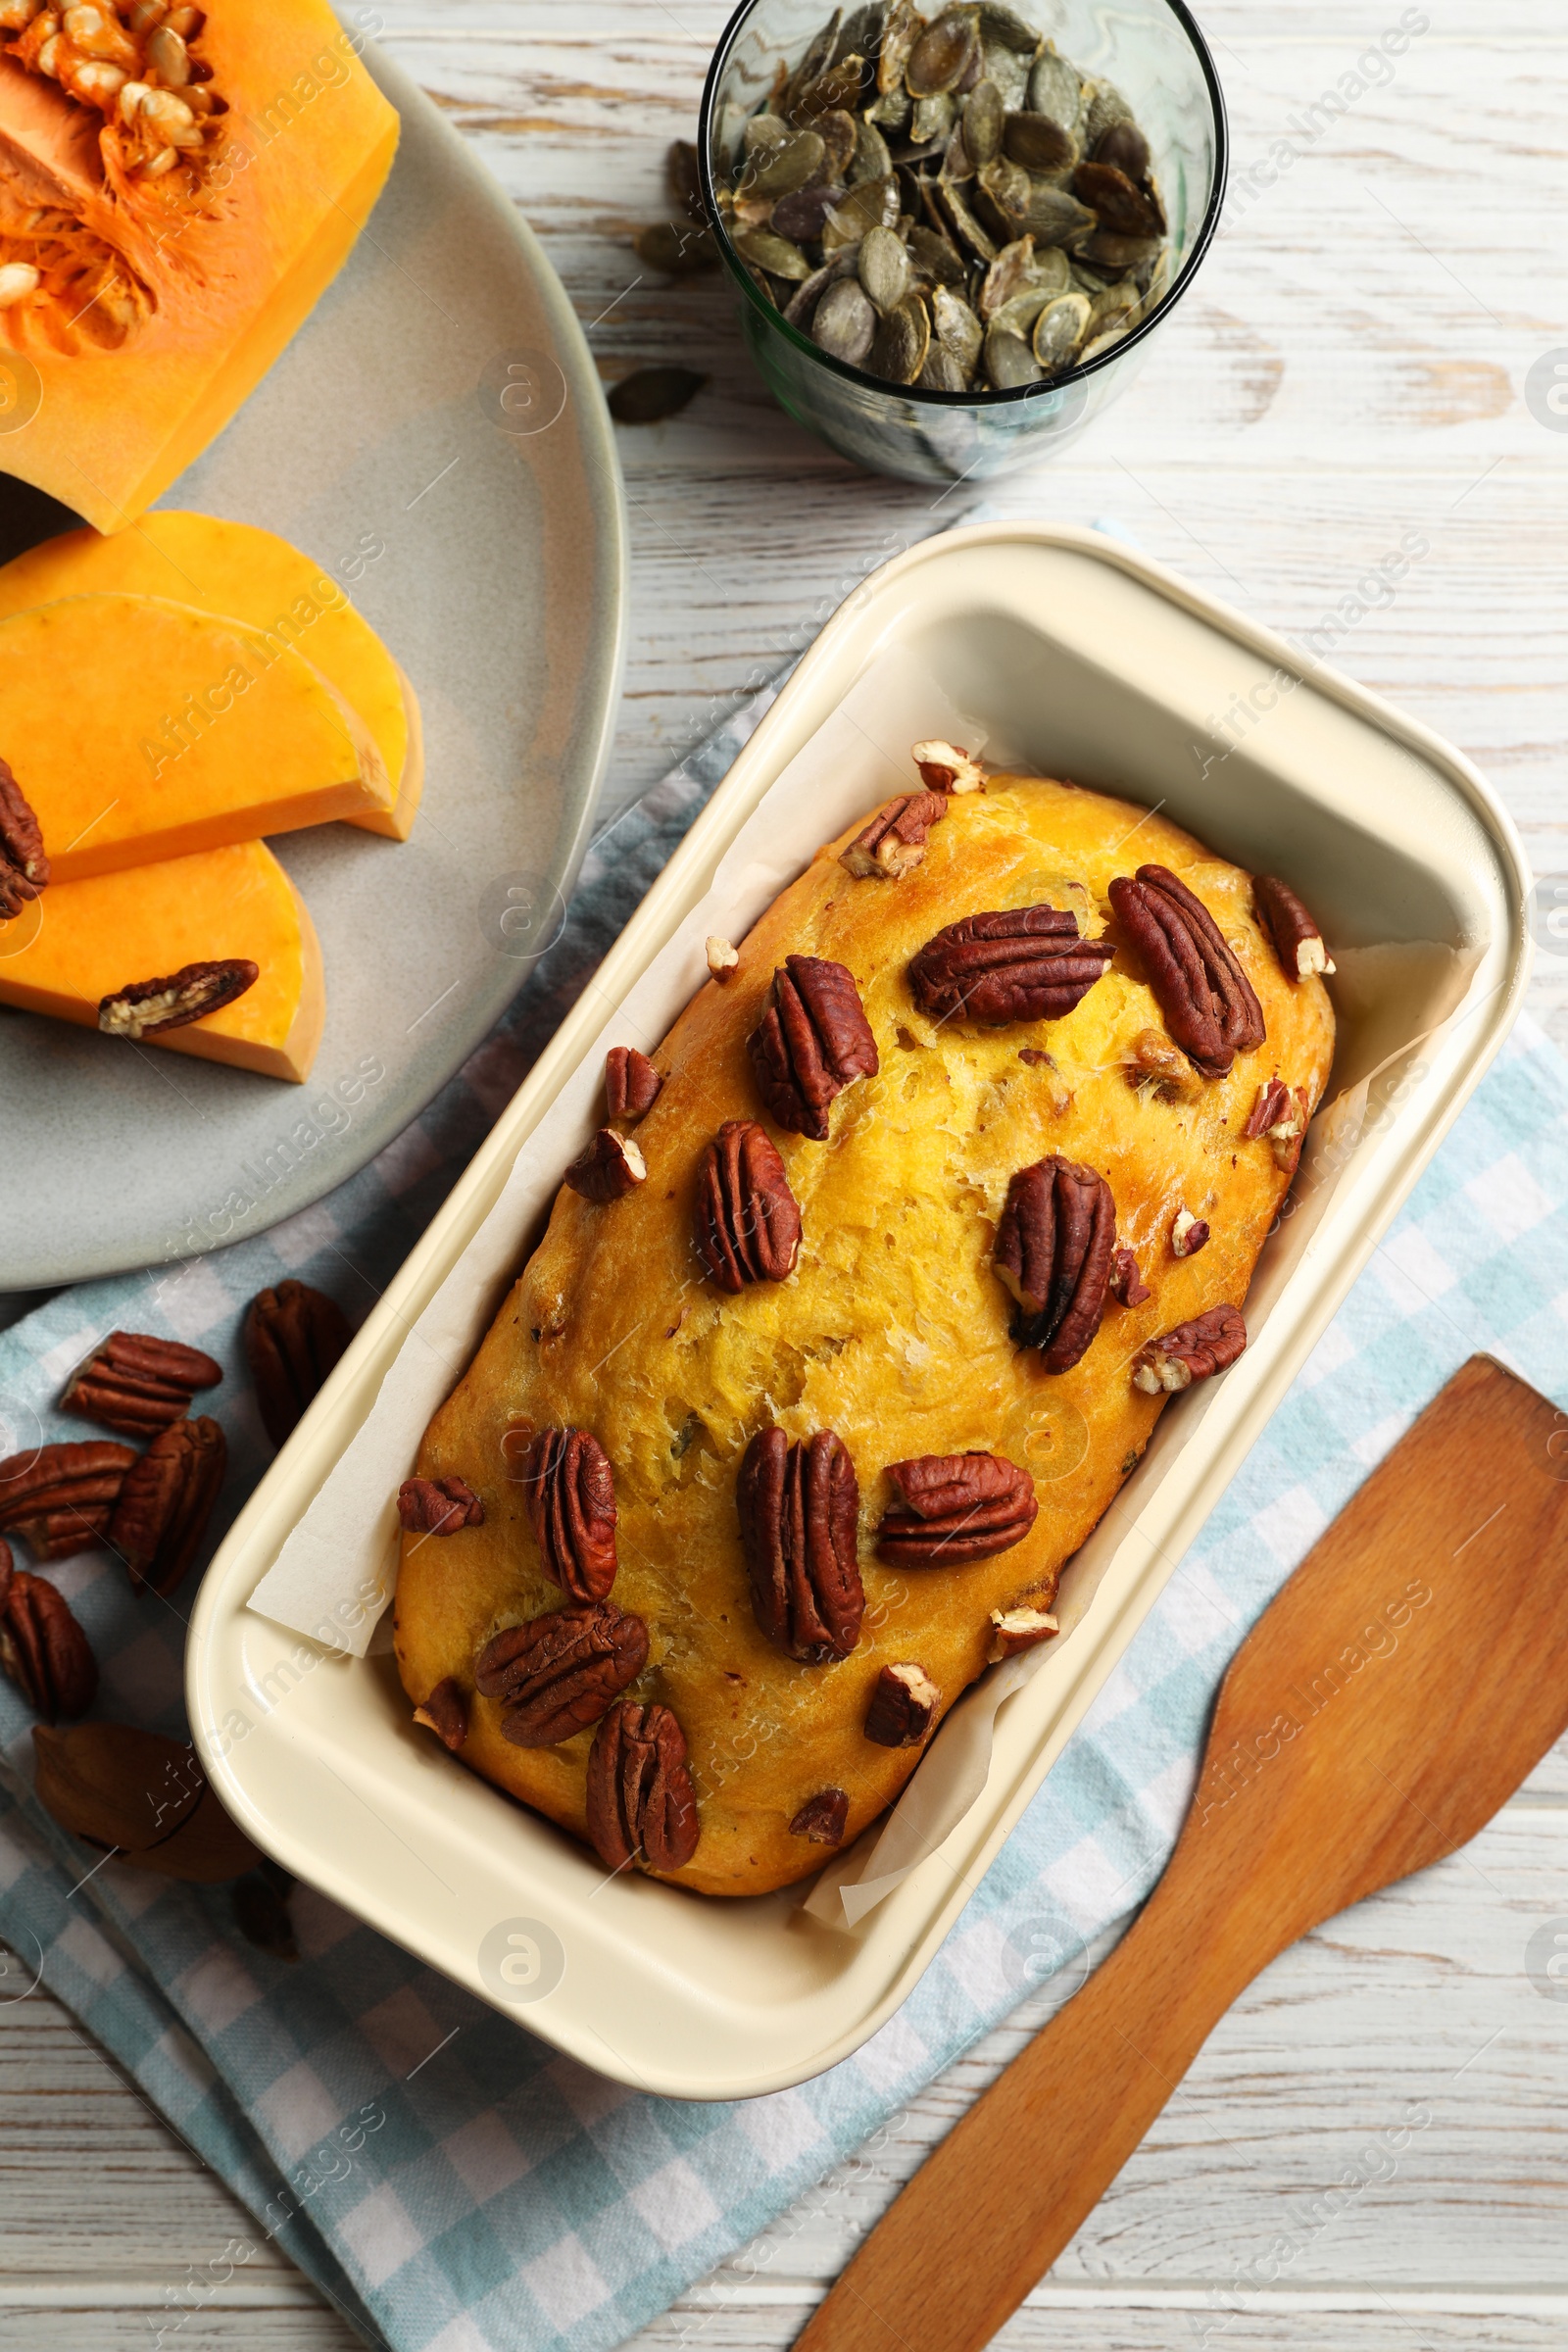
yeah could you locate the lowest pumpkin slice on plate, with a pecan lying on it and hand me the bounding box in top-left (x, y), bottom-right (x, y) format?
top-left (0, 842), bottom-right (326, 1084)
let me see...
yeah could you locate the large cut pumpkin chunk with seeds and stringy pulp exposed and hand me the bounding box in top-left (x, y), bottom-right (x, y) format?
top-left (0, 0), bottom-right (397, 531)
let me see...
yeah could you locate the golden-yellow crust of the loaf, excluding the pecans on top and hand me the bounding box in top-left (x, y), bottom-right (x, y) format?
top-left (395, 776), bottom-right (1333, 1895)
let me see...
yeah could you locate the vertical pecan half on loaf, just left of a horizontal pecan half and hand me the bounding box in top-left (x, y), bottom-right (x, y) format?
top-left (736, 1428), bottom-right (865, 1665)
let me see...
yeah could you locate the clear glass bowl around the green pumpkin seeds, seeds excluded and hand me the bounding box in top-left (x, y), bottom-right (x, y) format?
top-left (698, 0), bottom-right (1227, 482)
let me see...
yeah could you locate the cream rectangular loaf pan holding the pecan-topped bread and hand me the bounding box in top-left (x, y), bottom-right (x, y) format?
top-left (186, 524), bottom-right (1528, 2098)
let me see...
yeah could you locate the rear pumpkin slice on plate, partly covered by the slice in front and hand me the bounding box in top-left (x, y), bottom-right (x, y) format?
top-left (0, 508), bottom-right (425, 842)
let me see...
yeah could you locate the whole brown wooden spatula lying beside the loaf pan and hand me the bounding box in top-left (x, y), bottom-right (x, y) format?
top-left (797, 1354), bottom-right (1568, 2352)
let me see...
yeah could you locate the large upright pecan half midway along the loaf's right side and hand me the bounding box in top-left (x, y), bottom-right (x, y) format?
top-left (992, 1152), bottom-right (1116, 1371)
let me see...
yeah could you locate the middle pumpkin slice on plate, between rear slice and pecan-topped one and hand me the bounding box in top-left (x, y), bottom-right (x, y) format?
top-left (0, 593), bottom-right (393, 882)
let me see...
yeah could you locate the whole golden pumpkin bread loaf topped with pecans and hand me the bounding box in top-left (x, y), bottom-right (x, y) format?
top-left (397, 780), bottom-right (1333, 1895)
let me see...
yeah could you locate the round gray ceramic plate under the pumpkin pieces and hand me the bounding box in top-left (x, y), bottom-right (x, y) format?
top-left (0, 36), bottom-right (625, 1289)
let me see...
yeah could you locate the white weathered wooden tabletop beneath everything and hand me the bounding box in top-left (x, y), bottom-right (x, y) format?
top-left (0, 0), bottom-right (1568, 2352)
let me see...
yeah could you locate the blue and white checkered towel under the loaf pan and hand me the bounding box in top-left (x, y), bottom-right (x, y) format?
top-left (0, 639), bottom-right (1568, 2352)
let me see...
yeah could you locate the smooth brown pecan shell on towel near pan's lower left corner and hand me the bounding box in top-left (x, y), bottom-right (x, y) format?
top-left (33, 1724), bottom-right (264, 1886)
